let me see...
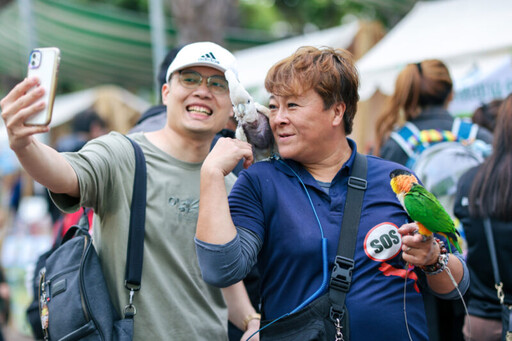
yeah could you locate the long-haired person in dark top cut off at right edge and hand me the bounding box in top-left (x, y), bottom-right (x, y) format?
top-left (454, 94), bottom-right (512, 341)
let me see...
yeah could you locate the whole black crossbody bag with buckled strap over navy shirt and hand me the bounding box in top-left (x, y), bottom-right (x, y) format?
top-left (261, 153), bottom-right (367, 341)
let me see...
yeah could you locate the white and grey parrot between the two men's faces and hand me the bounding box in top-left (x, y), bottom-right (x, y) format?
top-left (224, 69), bottom-right (275, 161)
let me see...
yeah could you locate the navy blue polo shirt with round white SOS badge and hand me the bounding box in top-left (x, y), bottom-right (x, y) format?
top-left (229, 140), bottom-right (427, 340)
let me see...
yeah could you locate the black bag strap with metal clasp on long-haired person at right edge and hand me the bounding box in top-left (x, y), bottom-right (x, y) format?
top-left (484, 218), bottom-right (512, 341)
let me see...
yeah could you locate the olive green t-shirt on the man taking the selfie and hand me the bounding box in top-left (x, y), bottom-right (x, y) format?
top-left (51, 133), bottom-right (235, 340)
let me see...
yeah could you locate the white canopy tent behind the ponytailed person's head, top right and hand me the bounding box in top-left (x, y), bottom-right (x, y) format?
top-left (357, 0), bottom-right (512, 113)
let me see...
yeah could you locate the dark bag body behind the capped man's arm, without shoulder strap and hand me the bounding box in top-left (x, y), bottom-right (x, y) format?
top-left (38, 214), bottom-right (125, 341)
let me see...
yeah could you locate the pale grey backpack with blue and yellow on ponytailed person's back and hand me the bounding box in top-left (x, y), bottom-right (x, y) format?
top-left (391, 118), bottom-right (491, 218)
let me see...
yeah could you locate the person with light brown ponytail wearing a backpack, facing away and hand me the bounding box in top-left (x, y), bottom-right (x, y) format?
top-left (373, 59), bottom-right (492, 341)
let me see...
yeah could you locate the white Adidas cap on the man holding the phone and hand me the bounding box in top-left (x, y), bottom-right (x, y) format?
top-left (165, 42), bottom-right (238, 81)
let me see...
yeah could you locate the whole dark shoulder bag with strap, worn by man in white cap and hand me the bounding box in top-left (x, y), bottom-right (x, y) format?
top-left (31, 138), bottom-right (146, 341)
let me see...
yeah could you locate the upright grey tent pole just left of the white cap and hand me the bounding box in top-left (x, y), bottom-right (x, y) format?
top-left (148, 0), bottom-right (166, 103)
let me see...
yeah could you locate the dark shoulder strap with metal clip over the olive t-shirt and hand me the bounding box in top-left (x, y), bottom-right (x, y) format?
top-left (124, 137), bottom-right (147, 317)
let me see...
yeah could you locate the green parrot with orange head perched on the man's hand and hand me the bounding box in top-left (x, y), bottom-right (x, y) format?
top-left (389, 169), bottom-right (462, 253)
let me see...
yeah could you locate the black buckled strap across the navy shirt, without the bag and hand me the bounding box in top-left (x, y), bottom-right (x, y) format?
top-left (329, 153), bottom-right (368, 325)
